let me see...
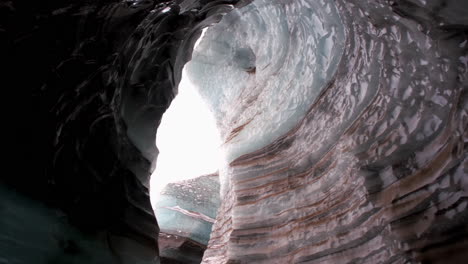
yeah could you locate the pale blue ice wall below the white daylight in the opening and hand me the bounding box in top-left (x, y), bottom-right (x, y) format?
top-left (153, 173), bottom-right (220, 264)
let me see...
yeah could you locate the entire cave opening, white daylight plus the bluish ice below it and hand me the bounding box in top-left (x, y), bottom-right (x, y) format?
top-left (150, 63), bottom-right (223, 263)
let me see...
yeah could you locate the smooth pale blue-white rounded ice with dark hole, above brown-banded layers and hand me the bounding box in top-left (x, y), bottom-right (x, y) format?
top-left (186, 0), bottom-right (345, 161)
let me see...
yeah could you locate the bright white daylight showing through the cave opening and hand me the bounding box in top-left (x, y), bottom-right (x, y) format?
top-left (151, 65), bottom-right (222, 206)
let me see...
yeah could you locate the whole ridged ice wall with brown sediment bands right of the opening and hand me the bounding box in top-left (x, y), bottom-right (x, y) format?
top-left (184, 0), bottom-right (468, 264)
